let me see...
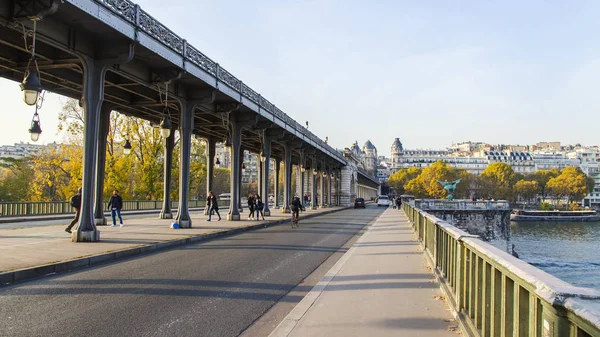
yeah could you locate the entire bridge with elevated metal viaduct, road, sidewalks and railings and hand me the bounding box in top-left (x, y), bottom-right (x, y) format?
top-left (0, 0), bottom-right (600, 337)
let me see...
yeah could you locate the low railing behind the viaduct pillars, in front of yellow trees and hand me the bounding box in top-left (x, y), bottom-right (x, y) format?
top-left (0, 200), bottom-right (229, 217)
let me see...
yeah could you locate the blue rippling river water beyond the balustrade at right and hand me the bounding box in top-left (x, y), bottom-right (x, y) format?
top-left (511, 222), bottom-right (600, 289)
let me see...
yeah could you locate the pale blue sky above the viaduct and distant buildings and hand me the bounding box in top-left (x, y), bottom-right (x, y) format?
top-left (0, 0), bottom-right (600, 155)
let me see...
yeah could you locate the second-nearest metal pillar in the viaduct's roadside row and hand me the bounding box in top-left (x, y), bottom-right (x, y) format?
top-left (175, 100), bottom-right (196, 228)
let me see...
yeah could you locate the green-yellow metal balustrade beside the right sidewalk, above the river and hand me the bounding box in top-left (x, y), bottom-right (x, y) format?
top-left (403, 203), bottom-right (600, 337)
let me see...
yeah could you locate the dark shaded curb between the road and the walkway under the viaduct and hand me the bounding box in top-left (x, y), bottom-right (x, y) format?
top-left (0, 207), bottom-right (351, 287)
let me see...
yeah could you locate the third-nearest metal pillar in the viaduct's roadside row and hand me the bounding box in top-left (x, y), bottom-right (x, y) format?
top-left (227, 118), bottom-right (242, 221)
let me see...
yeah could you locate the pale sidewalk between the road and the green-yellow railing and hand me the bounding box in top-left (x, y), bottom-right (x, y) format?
top-left (270, 209), bottom-right (459, 337)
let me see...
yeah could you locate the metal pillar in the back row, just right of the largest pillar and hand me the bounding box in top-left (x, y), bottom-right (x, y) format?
top-left (94, 102), bottom-right (112, 226)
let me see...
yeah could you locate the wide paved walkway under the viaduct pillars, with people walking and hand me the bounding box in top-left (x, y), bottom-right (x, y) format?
top-left (0, 207), bottom-right (345, 284)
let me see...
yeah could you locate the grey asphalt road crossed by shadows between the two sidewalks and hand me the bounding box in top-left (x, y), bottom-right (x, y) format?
top-left (0, 206), bottom-right (381, 336)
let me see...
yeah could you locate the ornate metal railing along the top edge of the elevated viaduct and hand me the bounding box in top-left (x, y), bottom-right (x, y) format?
top-left (94, 0), bottom-right (345, 162)
